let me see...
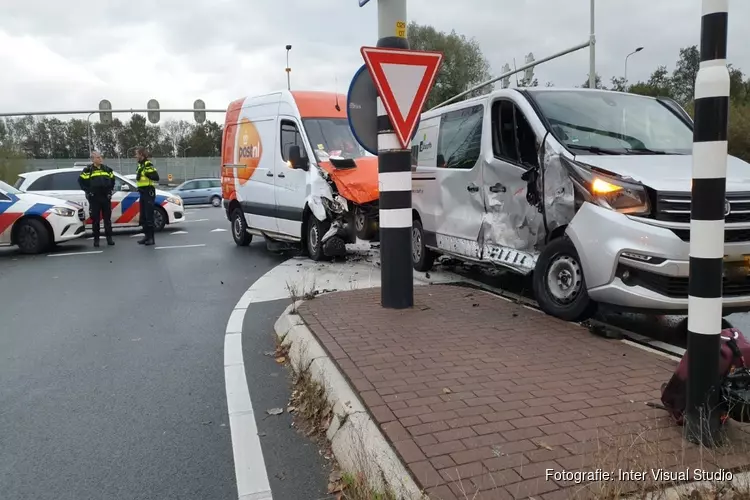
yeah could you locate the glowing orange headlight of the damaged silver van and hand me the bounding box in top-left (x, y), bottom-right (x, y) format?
top-left (563, 158), bottom-right (651, 215)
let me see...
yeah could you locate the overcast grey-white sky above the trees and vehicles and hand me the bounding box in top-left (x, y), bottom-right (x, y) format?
top-left (0, 0), bottom-right (750, 121)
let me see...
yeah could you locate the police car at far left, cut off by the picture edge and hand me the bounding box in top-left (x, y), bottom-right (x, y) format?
top-left (0, 181), bottom-right (85, 254)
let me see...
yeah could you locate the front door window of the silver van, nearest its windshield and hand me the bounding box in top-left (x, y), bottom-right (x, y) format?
top-left (492, 101), bottom-right (539, 166)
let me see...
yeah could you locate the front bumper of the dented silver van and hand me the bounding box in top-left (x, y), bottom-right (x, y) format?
top-left (566, 203), bottom-right (750, 314)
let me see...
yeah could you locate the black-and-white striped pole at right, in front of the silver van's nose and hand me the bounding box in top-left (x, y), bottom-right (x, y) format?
top-left (685, 0), bottom-right (729, 446)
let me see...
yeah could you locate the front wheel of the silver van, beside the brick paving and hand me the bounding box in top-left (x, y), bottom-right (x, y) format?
top-left (532, 237), bottom-right (596, 321)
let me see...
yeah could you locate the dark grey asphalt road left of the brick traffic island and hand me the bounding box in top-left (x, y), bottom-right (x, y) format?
top-left (0, 207), bottom-right (326, 500)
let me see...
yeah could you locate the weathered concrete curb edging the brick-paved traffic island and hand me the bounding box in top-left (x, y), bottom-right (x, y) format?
top-left (274, 301), bottom-right (427, 500)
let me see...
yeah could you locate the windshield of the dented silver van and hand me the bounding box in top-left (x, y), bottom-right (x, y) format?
top-left (529, 90), bottom-right (693, 154)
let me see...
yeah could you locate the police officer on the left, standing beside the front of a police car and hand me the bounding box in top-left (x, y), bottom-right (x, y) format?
top-left (78, 151), bottom-right (115, 247)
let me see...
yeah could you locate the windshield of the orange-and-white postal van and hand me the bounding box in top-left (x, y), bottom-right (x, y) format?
top-left (302, 118), bottom-right (367, 162)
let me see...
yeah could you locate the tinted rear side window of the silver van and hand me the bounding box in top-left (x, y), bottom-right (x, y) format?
top-left (437, 104), bottom-right (484, 169)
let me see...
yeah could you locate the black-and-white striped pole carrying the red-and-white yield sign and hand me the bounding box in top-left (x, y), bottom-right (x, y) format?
top-left (377, 0), bottom-right (414, 309)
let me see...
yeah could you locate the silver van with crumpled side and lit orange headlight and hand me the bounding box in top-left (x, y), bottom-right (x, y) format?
top-left (412, 88), bottom-right (750, 321)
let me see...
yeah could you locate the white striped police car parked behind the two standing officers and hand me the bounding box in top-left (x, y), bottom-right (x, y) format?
top-left (15, 166), bottom-right (185, 231)
